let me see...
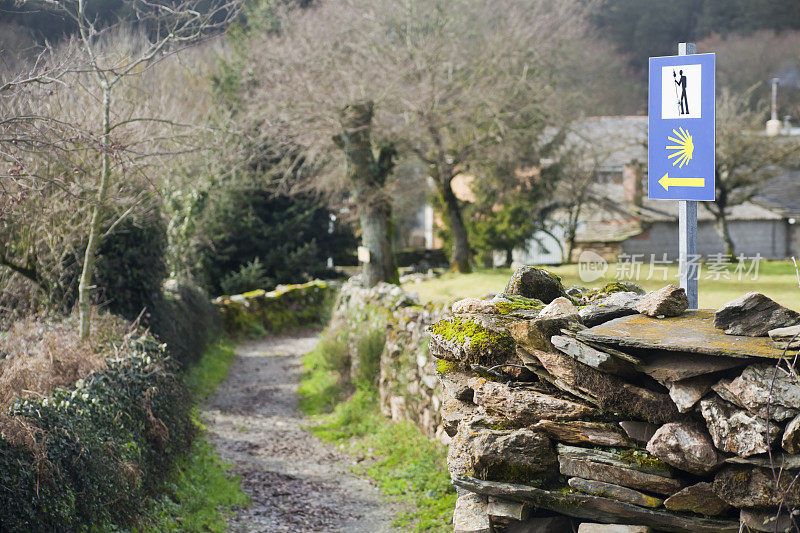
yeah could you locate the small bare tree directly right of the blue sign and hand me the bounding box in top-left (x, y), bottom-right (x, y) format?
top-left (702, 89), bottom-right (800, 256)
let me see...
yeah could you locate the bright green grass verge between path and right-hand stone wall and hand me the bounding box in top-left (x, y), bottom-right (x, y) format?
top-left (299, 334), bottom-right (456, 532)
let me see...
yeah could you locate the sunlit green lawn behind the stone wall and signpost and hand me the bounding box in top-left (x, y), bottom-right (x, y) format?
top-left (403, 261), bottom-right (800, 310)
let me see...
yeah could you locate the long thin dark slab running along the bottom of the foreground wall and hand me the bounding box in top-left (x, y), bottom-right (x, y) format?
top-left (453, 476), bottom-right (739, 533)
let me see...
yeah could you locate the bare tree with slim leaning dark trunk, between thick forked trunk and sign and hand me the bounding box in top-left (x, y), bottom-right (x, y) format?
top-left (384, 0), bottom-right (608, 272)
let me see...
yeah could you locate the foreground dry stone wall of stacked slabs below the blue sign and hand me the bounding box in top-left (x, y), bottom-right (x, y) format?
top-left (430, 267), bottom-right (800, 532)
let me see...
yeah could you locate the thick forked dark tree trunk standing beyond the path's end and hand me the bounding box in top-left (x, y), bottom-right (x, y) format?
top-left (334, 102), bottom-right (399, 287)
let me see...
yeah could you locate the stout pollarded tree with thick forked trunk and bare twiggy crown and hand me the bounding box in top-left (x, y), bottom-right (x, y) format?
top-left (238, 1), bottom-right (397, 286)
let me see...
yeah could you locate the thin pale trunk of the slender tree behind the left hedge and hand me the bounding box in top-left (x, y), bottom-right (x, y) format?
top-left (78, 82), bottom-right (111, 339)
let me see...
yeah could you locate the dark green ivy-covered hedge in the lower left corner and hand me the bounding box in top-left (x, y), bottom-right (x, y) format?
top-left (0, 336), bottom-right (193, 531)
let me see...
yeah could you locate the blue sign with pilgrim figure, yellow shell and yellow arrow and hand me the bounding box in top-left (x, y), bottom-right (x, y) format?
top-left (647, 54), bottom-right (715, 201)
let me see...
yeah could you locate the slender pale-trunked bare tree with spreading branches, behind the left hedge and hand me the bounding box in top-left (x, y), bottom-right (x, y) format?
top-left (0, 0), bottom-right (238, 338)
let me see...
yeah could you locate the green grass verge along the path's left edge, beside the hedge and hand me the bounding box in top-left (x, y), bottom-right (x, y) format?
top-left (134, 339), bottom-right (250, 533)
